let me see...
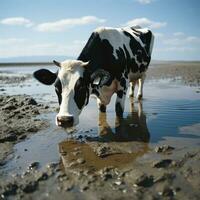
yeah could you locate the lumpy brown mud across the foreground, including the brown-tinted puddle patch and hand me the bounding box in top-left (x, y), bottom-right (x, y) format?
top-left (0, 140), bottom-right (200, 200)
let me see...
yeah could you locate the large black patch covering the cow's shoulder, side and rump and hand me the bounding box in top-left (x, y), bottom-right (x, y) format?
top-left (78, 28), bottom-right (151, 89)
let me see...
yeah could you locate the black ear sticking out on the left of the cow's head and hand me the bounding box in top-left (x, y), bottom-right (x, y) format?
top-left (33, 69), bottom-right (57, 85)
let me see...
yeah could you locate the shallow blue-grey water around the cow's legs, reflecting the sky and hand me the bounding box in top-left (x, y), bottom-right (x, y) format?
top-left (0, 66), bottom-right (200, 173)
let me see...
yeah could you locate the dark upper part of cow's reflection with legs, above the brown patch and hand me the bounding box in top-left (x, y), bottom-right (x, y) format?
top-left (90, 98), bottom-right (150, 142)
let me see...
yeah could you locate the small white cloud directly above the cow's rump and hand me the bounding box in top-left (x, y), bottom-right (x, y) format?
top-left (125, 17), bottom-right (167, 29)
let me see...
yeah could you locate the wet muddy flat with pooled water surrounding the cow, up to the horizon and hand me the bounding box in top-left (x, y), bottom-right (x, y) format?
top-left (0, 62), bottom-right (200, 200)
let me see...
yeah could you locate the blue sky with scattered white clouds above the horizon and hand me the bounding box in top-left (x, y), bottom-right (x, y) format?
top-left (0, 0), bottom-right (200, 61)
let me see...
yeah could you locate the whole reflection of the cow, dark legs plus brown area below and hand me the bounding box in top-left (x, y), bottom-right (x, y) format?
top-left (59, 101), bottom-right (150, 171)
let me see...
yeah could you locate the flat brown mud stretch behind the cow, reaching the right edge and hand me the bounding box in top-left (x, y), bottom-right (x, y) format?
top-left (147, 62), bottom-right (200, 86)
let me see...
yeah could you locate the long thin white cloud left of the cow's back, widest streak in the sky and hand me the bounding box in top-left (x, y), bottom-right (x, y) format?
top-left (36, 16), bottom-right (106, 32)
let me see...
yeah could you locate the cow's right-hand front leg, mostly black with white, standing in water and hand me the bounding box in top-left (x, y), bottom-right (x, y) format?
top-left (115, 89), bottom-right (127, 117)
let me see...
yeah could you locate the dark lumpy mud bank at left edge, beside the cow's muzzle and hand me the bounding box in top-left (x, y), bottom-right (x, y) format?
top-left (0, 95), bottom-right (49, 166)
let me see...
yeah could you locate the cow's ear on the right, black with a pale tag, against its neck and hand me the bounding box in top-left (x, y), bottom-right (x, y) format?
top-left (91, 69), bottom-right (111, 86)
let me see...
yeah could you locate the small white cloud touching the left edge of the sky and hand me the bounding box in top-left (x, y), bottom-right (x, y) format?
top-left (0, 17), bottom-right (33, 27)
